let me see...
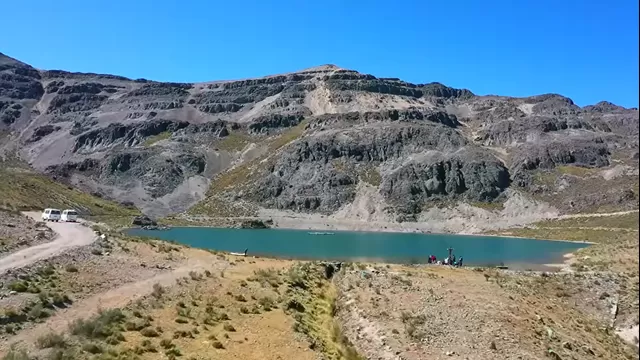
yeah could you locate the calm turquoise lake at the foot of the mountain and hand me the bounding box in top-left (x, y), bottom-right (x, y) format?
top-left (129, 227), bottom-right (588, 265)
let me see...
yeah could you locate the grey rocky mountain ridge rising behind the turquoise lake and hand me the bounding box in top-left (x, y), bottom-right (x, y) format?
top-left (0, 54), bottom-right (639, 221)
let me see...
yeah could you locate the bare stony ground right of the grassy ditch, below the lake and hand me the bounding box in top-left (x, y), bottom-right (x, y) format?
top-left (337, 266), bottom-right (637, 360)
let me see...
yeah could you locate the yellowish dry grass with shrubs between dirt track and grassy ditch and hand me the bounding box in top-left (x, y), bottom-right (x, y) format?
top-left (110, 259), bottom-right (315, 360)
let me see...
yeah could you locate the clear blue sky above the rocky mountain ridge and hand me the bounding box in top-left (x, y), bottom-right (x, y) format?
top-left (0, 0), bottom-right (638, 107)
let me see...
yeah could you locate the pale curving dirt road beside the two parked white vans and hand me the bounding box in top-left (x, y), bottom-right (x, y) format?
top-left (0, 212), bottom-right (96, 274)
